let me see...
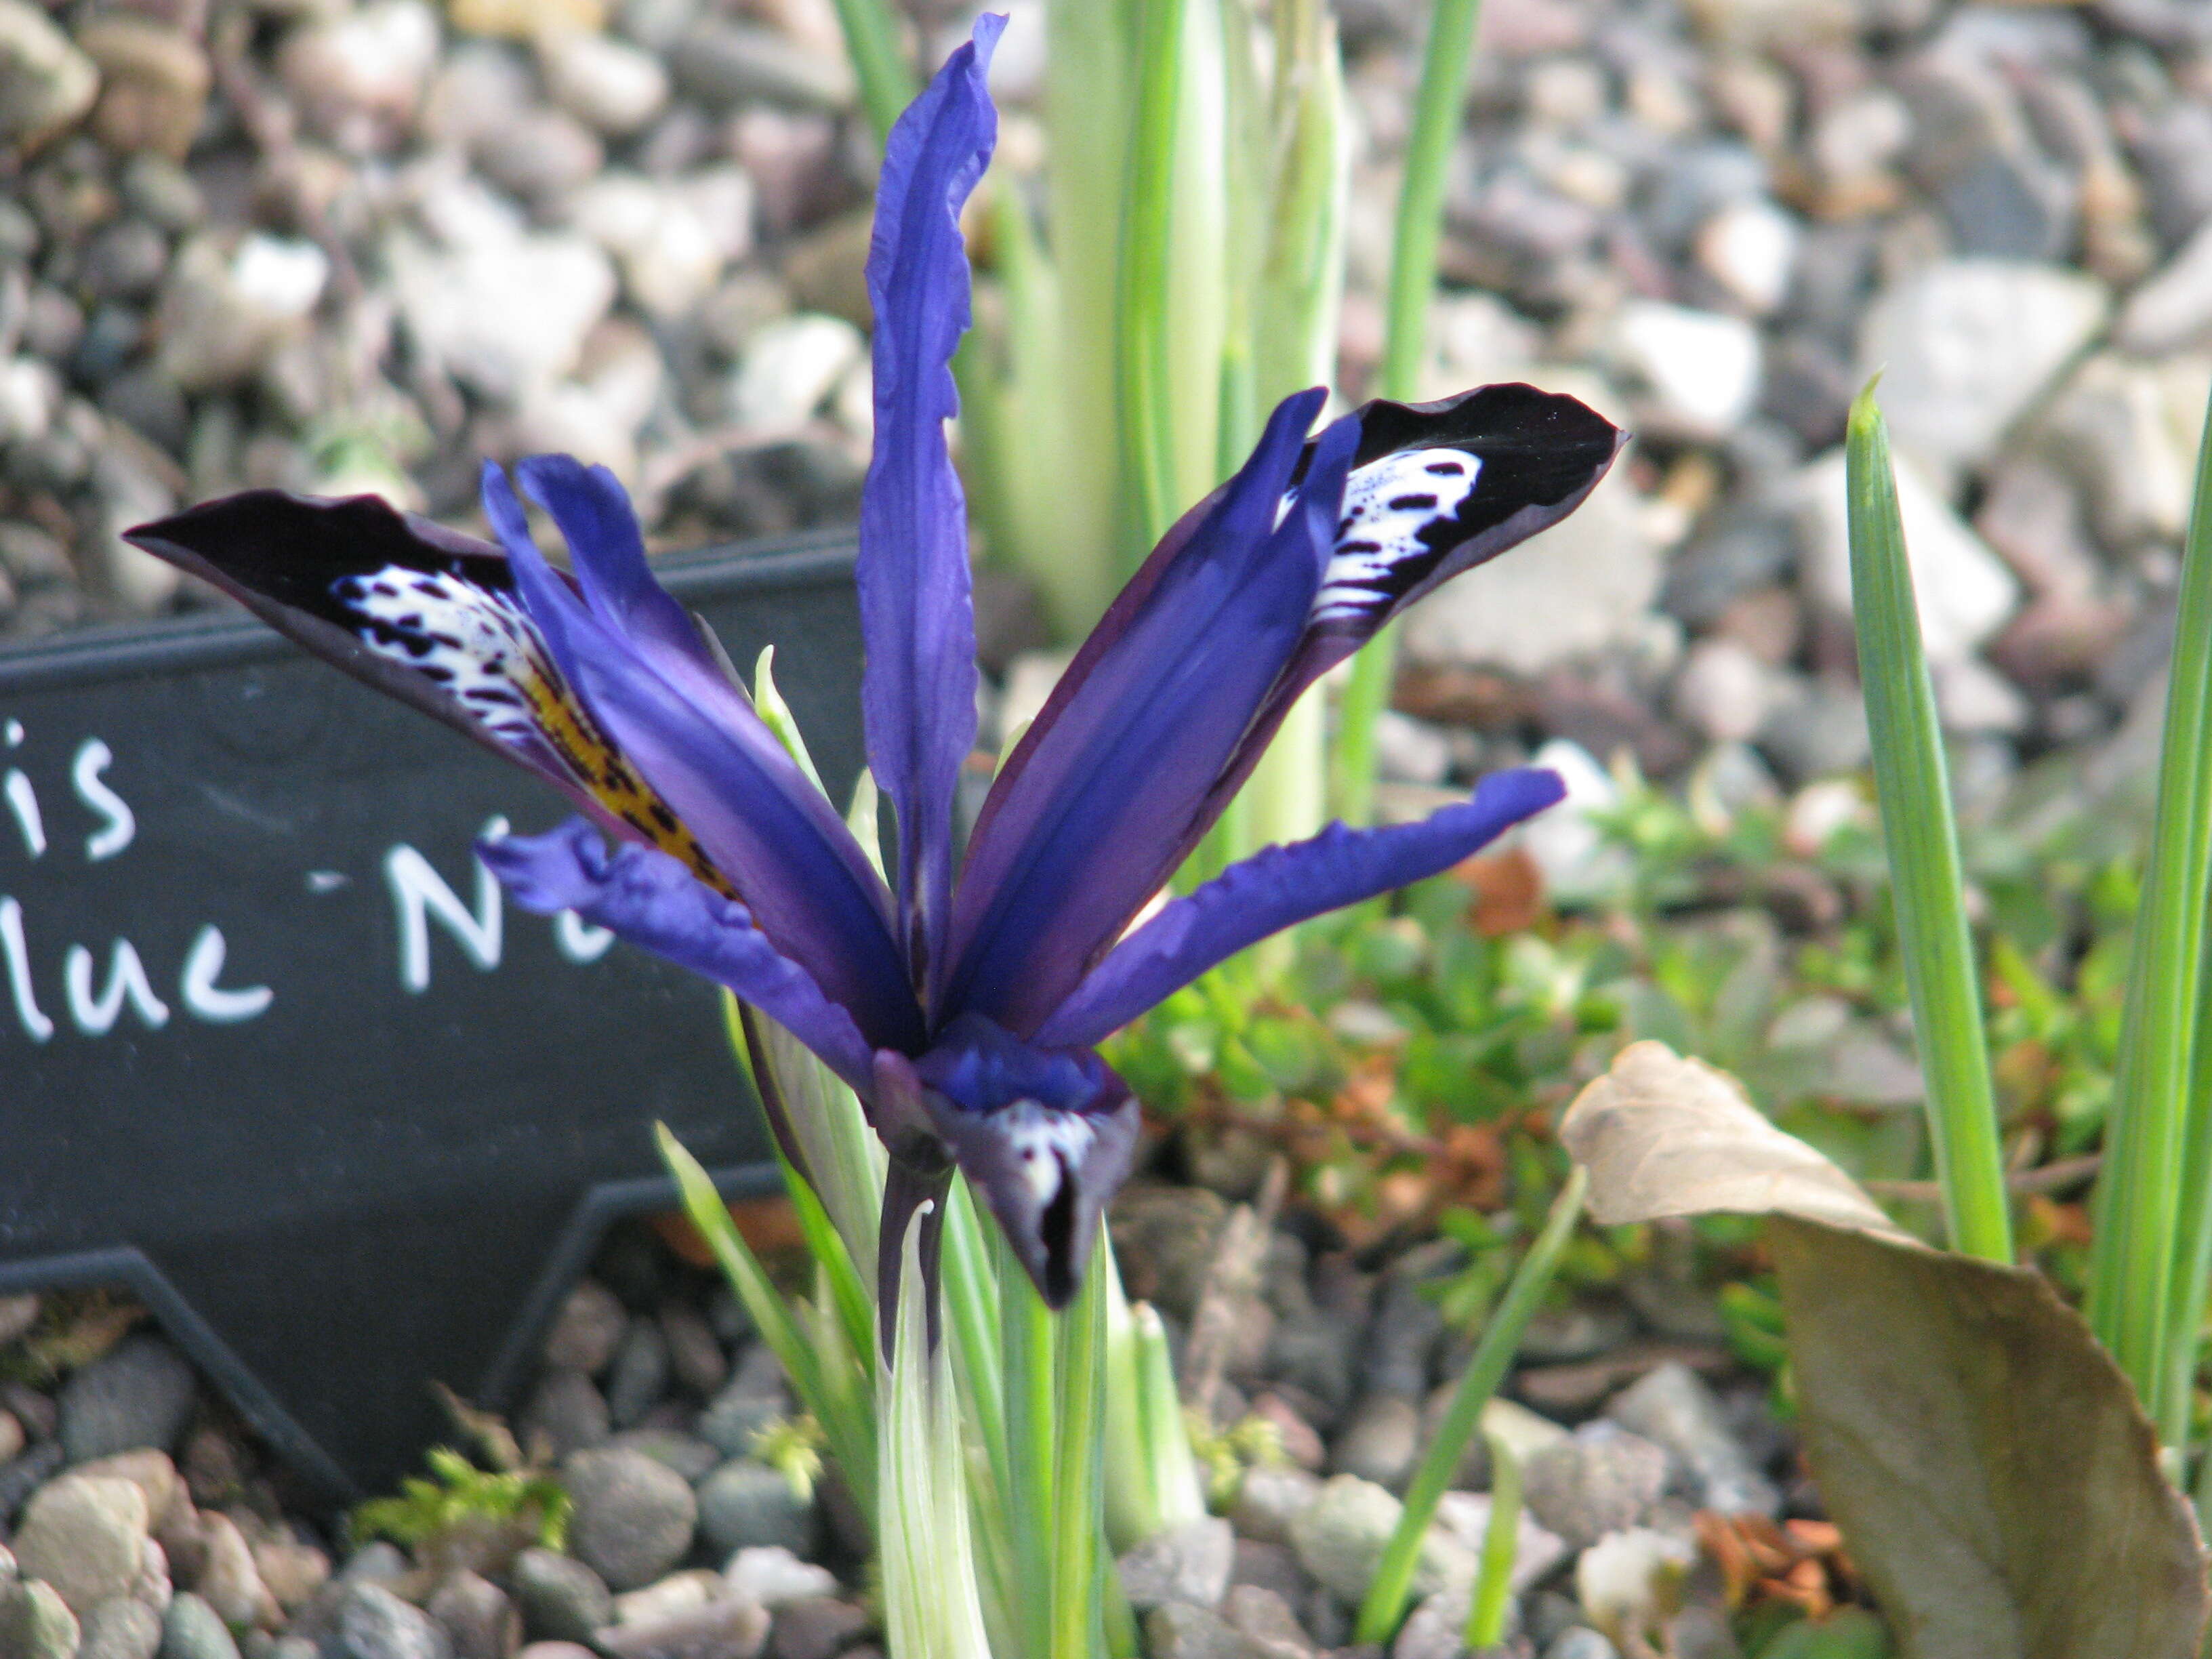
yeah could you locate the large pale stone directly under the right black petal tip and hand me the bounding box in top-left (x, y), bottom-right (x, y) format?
top-left (1405, 455), bottom-right (1664, 675)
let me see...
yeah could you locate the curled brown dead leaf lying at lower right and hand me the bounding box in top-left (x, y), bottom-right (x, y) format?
top-left (1559, 1042), bottom-right (2207, 1659)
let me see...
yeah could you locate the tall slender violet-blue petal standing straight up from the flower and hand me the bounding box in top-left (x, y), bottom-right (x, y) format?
top-left (858, 16), bottom-right (1006, 982)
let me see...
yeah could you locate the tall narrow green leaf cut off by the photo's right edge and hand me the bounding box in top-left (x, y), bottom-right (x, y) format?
top-left (2132, 373), bottom-right (2212, 1453)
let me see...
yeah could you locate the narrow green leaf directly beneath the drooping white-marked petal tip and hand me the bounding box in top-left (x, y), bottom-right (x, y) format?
top-left (1048, 1247), bottom-right (1111, 1659)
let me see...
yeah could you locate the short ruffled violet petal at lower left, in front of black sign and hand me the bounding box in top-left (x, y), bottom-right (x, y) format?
top-left (476, 819), bottom-right (874, 1106)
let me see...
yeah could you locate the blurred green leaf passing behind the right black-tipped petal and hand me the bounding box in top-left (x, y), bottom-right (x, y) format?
top-left (1336, 0), bottom-right (1482, 825)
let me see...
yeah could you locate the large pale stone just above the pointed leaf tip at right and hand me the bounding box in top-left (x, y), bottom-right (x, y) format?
top-left (1858, 259), bottom-right (2110, 469)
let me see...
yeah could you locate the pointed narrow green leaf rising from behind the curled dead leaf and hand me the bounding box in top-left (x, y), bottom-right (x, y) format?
top-left (1847, 385), bottom-right (2017, 1281)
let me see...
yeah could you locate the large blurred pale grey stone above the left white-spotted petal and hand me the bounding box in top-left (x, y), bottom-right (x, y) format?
top-left (389, 234), bottom-right (615, 403)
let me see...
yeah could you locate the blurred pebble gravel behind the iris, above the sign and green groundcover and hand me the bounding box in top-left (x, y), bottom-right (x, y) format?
top-left (0, 0), bottom-right (2212, 827)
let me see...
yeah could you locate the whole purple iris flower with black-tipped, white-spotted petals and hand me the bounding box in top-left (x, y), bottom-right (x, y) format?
top-left (131, 18), bottom-right (1622, 1305)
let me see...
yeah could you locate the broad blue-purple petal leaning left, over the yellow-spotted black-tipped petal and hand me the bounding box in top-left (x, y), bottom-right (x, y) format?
top-left (485, 467), bottom-right (922, 1046)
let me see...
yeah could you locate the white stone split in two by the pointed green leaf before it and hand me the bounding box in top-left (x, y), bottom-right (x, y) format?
top-left (1799, 449), bottom-right (2020, 663)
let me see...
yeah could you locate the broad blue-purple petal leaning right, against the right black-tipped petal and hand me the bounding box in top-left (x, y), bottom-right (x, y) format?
top-left (933, 392), bottom-right (1349, 1036)
